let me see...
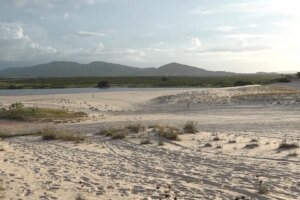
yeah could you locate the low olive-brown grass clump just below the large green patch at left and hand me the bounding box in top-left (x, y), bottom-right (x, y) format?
top-left (36, 128), bottom-right (85, 143)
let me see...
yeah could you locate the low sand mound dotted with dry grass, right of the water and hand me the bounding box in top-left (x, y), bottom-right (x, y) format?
top-left (153, 86), bottom-right (300, 105)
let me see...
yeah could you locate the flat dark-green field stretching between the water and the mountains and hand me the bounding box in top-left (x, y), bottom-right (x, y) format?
top-left (0, 74), bottom-right (279, 89)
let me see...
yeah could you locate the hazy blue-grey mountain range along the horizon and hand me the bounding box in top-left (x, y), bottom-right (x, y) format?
top-left (0, 61), bottom-right (235, 78)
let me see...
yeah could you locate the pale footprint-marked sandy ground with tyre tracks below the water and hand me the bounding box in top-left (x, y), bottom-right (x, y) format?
top-left (0, 86), bottom-right (300, 200)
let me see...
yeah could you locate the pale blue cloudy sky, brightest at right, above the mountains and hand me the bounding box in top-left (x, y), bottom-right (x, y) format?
top-left (0, 0), bottom-right (300, 72)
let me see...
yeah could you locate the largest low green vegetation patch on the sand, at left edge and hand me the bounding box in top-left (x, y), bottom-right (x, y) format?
top-left (0, 102), bottom-right (86, 121)
